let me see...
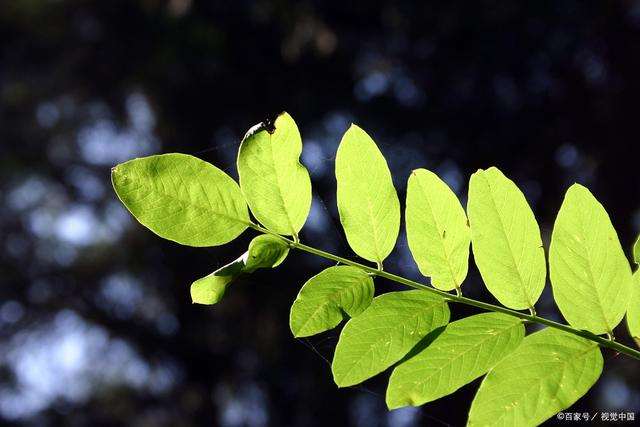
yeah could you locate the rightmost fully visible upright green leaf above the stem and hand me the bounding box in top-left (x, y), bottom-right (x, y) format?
top-left (549, 184), bottom-right (632, 334)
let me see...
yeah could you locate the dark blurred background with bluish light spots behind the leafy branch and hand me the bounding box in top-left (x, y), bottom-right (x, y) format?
top-left (0, 0), bottom-right (640, 426)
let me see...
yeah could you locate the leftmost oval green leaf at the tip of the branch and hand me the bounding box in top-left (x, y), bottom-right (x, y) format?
top-left (111, 153), bottom-right (249, 246)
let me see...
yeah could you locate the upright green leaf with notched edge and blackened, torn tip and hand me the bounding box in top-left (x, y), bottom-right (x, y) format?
top-left (238, 113), bottom-right (311, 236)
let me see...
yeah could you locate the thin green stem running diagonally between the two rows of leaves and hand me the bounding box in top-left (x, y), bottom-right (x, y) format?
top-left (251, 224), bottom-right (640, 360)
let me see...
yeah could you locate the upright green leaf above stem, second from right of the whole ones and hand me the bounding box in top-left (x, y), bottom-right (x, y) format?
top-left (467, 167), bottom-right (547, 310)
